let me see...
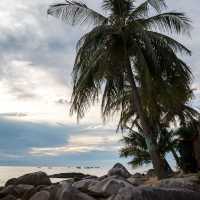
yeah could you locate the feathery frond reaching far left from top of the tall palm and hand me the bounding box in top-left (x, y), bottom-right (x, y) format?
top-left (47, 0), bottom-right (107, 25)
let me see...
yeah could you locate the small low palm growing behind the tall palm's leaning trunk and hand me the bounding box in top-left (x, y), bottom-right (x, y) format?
top-left (120, 127), bottom-right (175, 174)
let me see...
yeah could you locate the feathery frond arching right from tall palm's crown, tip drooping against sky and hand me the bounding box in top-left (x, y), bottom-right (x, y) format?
top-left (140, 12), bottom-right (191, 34)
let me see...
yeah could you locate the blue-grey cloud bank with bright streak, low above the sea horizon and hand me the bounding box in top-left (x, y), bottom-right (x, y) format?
top-left (0, 116), bottom-right (121, 165)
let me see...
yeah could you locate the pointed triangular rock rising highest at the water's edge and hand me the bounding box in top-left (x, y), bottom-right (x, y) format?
top-left (108, 163), bottom-right (131, 178)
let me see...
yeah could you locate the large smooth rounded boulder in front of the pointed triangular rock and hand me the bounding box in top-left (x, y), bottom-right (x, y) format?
top-left (88, 177), bottom-right (133, 197)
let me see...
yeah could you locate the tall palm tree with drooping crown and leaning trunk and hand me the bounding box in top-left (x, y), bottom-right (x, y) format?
top-left (48, 0), bottom-right (191, 178)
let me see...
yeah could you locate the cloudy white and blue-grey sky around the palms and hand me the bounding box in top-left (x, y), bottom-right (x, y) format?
top-left (0, 0), bottom-right (200, 165)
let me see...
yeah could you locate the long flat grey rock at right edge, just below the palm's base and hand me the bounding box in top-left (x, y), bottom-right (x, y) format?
top-left (158, 175), bottom-right (200, 192)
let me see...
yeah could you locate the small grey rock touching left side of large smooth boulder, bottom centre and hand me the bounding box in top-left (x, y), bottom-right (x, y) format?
top-left (72, 179), bottom-right (99, 192)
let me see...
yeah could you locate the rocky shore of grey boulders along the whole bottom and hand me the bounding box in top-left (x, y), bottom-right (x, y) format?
top-left (0, 163), bottom-right (200, 200)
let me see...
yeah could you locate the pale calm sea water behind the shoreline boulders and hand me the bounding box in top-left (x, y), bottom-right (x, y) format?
top-left (0, 166), bottom-right (149, 186)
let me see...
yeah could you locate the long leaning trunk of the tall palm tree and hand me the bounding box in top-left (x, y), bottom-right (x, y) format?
top-left (127, 62), bottom-right (168, 179)
